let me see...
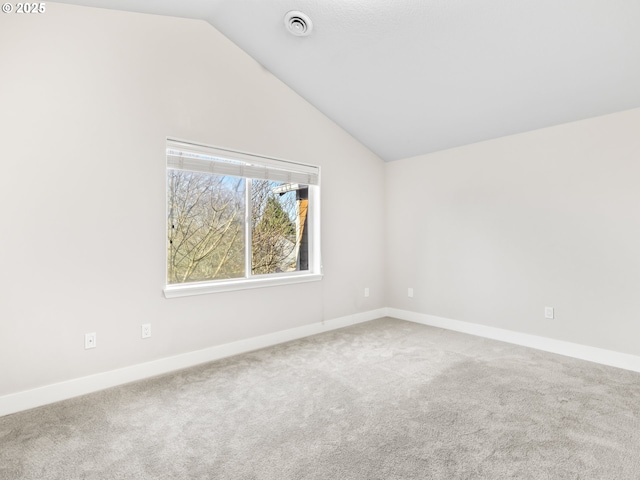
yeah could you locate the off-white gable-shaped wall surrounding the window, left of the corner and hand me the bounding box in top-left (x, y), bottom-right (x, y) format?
top-left (0, 3), bottom-right (386, 396)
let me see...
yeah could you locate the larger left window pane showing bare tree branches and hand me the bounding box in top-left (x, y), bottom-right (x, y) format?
top-left (167, 169), bottom-right (246, 284)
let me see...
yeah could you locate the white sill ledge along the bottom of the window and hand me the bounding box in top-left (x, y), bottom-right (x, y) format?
top-left (164, 273), bottom-right (322, 298)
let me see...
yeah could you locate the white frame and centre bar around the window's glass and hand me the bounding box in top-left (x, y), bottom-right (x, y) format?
top-left (163, 138), bottom-right (322, 298)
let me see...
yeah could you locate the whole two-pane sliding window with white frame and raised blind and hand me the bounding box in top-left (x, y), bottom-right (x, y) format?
top-left (164, 140), bottom-right (321, 297)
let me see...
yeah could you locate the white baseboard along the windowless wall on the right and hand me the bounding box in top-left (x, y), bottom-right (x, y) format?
top-left (386, 308), bottom-right (640, 372)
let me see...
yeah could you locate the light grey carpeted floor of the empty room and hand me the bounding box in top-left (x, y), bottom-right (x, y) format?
top-left (0, 318), bottom-right (640, 480)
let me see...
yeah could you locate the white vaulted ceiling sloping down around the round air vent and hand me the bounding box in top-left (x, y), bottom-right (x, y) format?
top-left (55, 0), bottom-right (640, 160)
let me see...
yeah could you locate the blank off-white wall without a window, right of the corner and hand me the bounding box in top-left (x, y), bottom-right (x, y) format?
top-left (385, 109), bottom-right (640, 355)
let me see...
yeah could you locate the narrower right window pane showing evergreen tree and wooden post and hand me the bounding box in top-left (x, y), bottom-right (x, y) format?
top-left (251, 180), bottom-right (309, 275)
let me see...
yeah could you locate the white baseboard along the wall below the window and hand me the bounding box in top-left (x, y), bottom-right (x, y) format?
top-left (0, 308), bottom-right (386, 417)
